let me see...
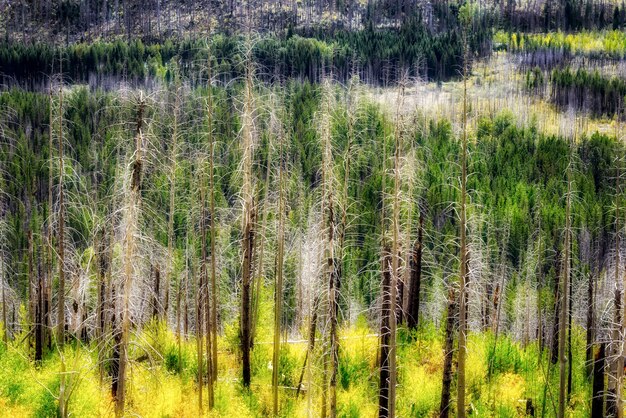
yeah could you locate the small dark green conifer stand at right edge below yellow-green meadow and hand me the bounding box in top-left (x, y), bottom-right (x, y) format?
top-left (550, 68), bottom-right (626, 117)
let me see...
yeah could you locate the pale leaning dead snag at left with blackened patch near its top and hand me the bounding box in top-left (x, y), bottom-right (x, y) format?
top-left (115, 93), bottom-right (146, 417)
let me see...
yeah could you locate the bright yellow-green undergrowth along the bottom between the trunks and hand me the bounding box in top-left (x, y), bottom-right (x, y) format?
top-left (0, 319), bottom-right (590, 417)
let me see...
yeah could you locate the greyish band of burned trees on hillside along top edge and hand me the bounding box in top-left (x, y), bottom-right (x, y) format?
top-left (0, 0), bottom-right (626, 42)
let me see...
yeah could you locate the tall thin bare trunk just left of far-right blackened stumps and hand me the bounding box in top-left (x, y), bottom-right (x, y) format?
top-left (558, 140), bottom-right (573, 418)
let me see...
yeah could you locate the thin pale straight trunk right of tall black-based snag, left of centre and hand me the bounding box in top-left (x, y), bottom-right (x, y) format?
top-left (267, 119), bottom-right (285, 416)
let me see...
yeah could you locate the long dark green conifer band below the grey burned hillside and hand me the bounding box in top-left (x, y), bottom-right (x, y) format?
top-left (0, 17), bottom-right (491, 85)
